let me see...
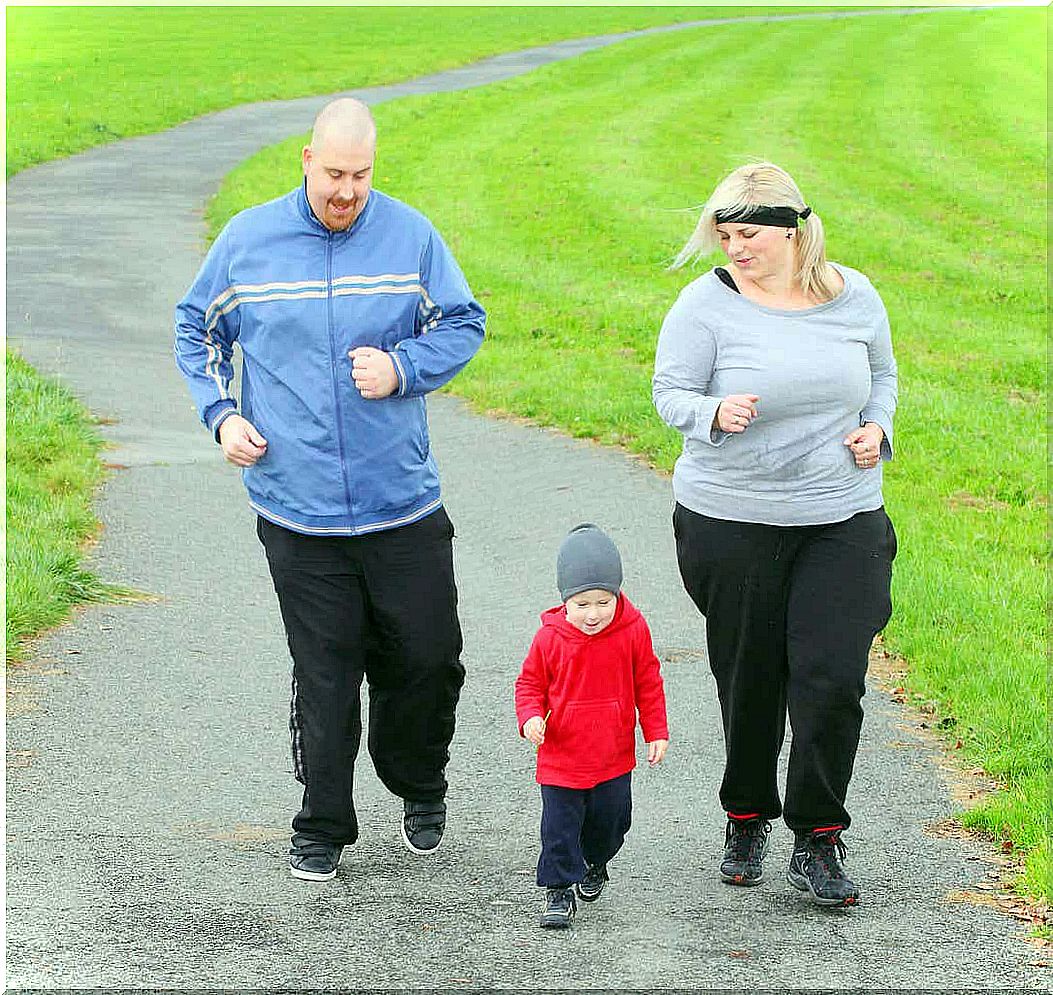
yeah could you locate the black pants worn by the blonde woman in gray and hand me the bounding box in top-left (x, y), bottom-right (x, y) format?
top-left (673, 504), bottom-right (896, 832)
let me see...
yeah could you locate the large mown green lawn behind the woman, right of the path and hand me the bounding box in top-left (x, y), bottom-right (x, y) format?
top-left (211, 9), bottom-right (1053, 897)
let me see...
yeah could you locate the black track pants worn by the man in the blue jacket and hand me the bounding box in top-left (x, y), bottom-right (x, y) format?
top-left (257, 508), bottom-right (464, 844)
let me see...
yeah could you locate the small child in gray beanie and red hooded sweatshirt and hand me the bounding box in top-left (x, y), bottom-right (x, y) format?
top-left (516, 524), bottom-right (669, 929)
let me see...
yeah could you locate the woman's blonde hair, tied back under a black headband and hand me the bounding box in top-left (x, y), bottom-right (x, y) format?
top-left (670, 162), bottom-right (838, 301)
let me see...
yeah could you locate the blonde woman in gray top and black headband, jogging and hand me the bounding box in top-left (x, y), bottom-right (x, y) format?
top-left (653, 163), bottom-right (896, 906)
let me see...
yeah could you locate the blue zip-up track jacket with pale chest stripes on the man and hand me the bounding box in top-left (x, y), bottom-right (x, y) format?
top-left (176, 186), bottom-right (485, 536)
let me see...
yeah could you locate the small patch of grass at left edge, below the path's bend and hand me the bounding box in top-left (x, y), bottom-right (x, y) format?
top-left (5, 351), bottom-right (116, 662)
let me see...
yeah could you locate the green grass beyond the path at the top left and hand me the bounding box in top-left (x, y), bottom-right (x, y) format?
top-left (6, 6), bottom-right (812, 176)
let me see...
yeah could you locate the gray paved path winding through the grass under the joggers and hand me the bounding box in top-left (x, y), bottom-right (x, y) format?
top-left (6, 9), bottom-right (1048, 990)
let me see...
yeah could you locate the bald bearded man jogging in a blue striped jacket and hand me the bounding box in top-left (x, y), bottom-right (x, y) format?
top-left (176, 99), bottom-right (485, 881)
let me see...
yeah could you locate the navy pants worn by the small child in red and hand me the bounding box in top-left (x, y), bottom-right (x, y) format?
top-left (537, 773), bottom-right (633, 888)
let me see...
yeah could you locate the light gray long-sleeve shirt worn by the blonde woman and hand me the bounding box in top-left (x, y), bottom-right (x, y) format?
top-left (652, 265), bottom-right (896, 525)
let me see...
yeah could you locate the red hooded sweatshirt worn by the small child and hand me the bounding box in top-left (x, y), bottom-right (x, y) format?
top-left (516, 594), bottom-right (669, 788)
